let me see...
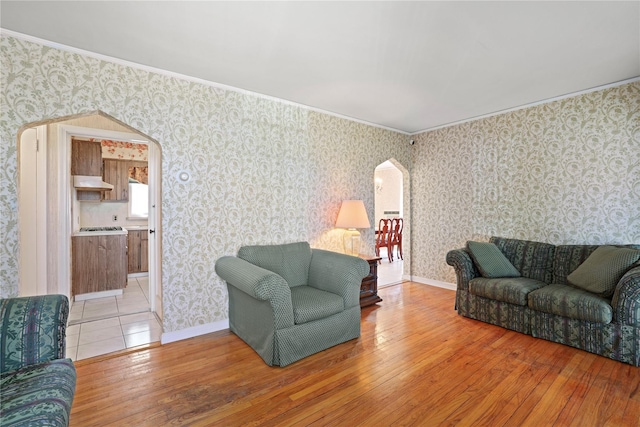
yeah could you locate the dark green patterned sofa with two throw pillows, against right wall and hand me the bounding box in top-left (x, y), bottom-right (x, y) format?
top-left (446, 237), bottom-right (640, 366)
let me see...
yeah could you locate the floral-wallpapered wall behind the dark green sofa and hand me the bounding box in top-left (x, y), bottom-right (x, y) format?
top-left (412, 82), bottom-right (640, 283)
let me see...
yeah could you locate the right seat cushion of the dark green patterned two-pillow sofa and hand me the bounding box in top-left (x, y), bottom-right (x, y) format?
top-left (529, 284), bottom-right (613, 324)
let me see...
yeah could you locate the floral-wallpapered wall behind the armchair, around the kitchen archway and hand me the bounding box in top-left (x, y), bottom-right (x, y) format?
top-left (0, 37), bottom-right (411, 332)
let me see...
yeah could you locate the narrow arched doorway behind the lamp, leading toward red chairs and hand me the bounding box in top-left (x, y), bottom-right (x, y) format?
top-left (374, 159), bottom-right (410, 287)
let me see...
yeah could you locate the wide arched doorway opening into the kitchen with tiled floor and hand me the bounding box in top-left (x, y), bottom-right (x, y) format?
top-left (18, 111), bottom-right (162, 360)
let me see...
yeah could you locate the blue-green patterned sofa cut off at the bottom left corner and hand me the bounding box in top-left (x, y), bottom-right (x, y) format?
top-left (0, 295), bottom-right (76, 427)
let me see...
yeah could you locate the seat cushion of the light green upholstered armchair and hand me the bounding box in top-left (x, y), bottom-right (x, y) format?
top-left (291, 286), bottom-right (344, 325)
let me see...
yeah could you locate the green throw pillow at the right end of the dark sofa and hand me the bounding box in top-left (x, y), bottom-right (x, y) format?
top-left (567, 246), bottom-right (640, 298)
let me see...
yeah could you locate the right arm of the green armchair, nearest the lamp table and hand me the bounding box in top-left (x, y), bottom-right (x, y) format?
top-left (308, 249), bottom-right (369, 308)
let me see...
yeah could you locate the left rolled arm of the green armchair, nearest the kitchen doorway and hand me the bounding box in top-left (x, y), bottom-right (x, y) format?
top-left (215, 256), bottom-right (293, 327)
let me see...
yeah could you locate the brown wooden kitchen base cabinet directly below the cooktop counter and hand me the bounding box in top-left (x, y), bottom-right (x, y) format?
top-left (71, 234), bottom-right (127, 295)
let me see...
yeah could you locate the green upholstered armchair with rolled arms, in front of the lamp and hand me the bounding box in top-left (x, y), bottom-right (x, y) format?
top-left (216, 242), bottom-right (369, 366)
